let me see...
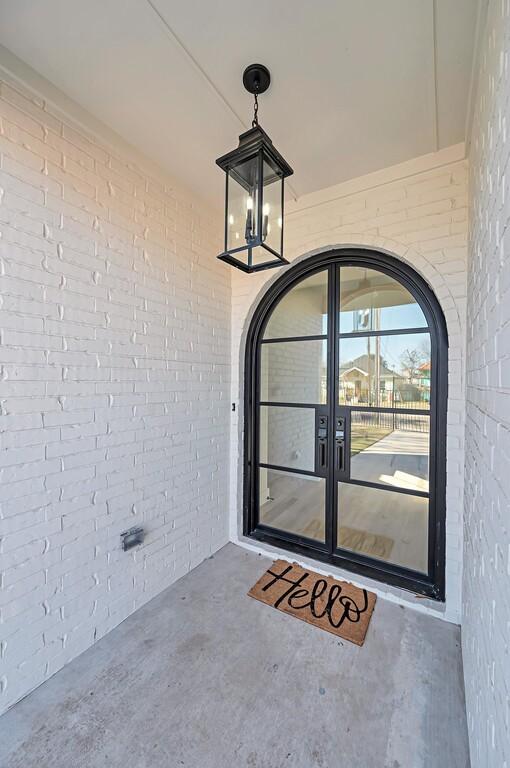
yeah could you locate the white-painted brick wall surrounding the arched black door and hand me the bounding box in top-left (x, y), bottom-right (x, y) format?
top-left (230, 145), bottom-right (467, 622)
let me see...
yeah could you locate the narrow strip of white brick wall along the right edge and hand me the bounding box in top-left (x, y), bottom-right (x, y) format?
top-left (462, 0), bottom-right (510, 768)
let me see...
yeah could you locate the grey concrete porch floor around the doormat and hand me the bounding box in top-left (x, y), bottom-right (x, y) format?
top-left (0, 544), bottom-right (469, 768)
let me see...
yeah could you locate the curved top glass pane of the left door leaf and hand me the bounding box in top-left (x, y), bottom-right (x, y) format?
top-left (264, 270), bottom-right (328, 339)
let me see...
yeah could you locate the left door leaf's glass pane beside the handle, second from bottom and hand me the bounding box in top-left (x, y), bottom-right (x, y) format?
top-left (259, 405), bottom-right (315, 472)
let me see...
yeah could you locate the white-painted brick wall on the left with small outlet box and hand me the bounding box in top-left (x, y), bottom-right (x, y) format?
top-left (0, 70), bottom-right (231, 711)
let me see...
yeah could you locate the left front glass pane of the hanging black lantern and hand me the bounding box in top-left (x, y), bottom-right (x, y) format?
top-left (226, 157), bottom-right (259, 251)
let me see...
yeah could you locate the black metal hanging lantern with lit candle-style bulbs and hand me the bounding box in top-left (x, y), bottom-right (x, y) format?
top-left (216, 64), bottom-right (293, 272)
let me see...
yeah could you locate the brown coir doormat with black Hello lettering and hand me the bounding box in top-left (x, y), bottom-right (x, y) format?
top-left (248, 560), bottom-right (376, 645)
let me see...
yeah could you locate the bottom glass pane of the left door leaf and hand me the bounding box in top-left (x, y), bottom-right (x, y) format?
top-left (259, 467), bottom-right (326, 541)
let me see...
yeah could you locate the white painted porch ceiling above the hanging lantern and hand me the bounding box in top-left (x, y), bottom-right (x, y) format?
top-left (0, 0), bottom-right (478, 202)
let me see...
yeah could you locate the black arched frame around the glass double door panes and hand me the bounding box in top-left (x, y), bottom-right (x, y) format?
top-left (243, 248), bottom-right (448, 601)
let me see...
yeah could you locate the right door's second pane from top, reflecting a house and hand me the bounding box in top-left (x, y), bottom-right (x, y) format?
top-left (339, 333), bottom-right (431, 409)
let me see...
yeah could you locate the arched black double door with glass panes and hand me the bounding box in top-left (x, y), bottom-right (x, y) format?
top-left (244, 248), bottom-right (448, 600)
